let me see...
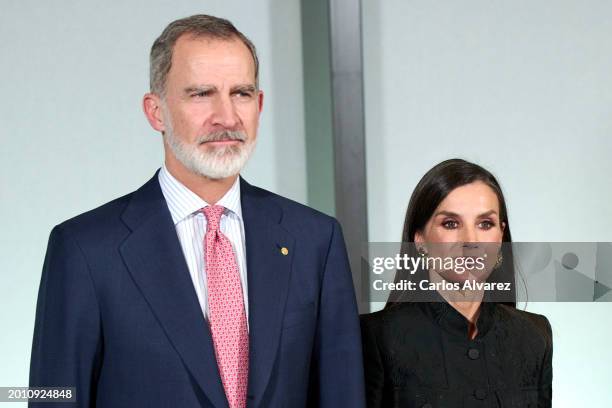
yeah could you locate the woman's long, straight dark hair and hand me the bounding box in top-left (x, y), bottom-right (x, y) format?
top-left (385, 159), bottom-right (516, 307)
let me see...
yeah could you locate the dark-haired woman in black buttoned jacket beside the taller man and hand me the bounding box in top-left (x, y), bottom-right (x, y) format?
top-left (362, 159), bottom-right (552, 408)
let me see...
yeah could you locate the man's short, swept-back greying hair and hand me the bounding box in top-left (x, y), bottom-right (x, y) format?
top-left (149, 14), bottom-right (259, 97)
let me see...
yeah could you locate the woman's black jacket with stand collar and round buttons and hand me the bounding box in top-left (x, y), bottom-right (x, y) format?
top-left (361, 302), bottom-right (552, 408)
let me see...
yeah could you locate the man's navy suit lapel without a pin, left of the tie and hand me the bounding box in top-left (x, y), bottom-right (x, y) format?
top-left (120, 174), bottom-right (228, 407)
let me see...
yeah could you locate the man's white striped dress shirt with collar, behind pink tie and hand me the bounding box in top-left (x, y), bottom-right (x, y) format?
top-left (158, 164), bottom-right (249, 324)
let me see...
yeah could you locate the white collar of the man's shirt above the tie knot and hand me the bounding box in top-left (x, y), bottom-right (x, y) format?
top-left (158, 163), bottom-right (242, 225)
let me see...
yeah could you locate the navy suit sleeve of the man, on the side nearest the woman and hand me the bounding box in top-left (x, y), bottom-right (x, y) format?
top-left (309, 220), bottom-right (365, 408)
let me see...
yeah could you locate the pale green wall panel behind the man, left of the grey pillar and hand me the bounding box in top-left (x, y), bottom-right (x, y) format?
top-left (0, 0), bottom-right (307, 407)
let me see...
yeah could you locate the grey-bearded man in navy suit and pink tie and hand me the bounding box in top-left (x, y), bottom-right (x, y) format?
top-left (30, 15), bottom-right (364, 408)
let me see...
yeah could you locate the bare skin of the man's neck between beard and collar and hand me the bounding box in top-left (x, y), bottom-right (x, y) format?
top-left (166, 160), bottom-right (238, 205)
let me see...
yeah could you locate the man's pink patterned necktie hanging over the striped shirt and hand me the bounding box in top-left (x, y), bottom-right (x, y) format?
top-left (202, 205), bottom-right (249, 408)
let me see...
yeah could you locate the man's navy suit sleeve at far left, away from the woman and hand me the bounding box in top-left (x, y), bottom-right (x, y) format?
top-left (29, 226), bottom-right (102, 408)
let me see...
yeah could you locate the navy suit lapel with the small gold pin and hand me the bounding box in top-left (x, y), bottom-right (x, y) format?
top-left (240, 179), bottom-right (294, 407)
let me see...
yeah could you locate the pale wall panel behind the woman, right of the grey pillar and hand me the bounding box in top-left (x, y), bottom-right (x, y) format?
top-left (362, 0), bottom-right (612, 407)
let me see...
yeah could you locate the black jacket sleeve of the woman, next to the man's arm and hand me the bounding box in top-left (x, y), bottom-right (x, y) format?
top-left (361, 315), bottom-right (385, 408)
